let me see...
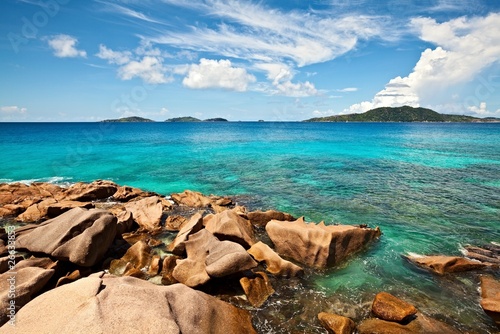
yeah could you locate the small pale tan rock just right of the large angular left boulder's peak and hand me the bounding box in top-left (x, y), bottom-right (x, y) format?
top-left (125, 196), bottom-right (163, 231)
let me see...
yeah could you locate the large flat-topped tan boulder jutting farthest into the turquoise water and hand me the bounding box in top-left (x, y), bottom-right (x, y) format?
top-left (266, 218), bottom-right (380, 268)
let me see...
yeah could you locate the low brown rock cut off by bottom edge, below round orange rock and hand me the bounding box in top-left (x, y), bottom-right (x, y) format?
top-left (358, 313), bottom-right (460, 334)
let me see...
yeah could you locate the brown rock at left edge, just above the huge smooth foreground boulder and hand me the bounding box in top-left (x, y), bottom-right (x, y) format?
top-left (0, 267), bottom-right (54, 326)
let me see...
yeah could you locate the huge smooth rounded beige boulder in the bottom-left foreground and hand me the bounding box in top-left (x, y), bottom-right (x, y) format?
top-left (0, 275), bottom-right (256, 334)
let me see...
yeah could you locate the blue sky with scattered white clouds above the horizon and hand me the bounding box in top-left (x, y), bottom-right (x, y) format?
top-left (0, 0), bottom-right (500, 122)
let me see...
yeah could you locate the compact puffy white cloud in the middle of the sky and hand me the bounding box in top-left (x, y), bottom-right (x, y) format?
top-left (182, 58), bottom-right (256, 92)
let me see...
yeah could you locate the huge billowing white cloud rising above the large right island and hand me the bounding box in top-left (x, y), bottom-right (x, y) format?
top-left (349, 13), bottom-right (500, 112)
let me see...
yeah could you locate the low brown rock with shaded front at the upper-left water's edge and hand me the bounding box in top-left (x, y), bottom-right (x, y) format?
top-left (64, 180), bottom-right (119, 202)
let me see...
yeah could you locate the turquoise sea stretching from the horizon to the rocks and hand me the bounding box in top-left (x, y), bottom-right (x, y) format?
top-left (0, 122), bottom-right (500, 333)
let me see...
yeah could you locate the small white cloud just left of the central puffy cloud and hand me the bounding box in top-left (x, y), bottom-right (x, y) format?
top-left (118, 56), bottom-right (171, 84)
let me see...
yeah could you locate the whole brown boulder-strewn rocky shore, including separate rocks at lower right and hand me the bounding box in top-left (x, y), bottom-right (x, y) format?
top-left (0, 180), bottom-right (500, 334)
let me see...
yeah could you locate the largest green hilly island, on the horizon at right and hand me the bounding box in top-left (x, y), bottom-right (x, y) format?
top-left (304, 106), bottom-right (500, 123)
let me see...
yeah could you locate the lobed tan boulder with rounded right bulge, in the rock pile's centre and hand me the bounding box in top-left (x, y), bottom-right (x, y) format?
top-left (172, 229), bottom-right (257, 287)
